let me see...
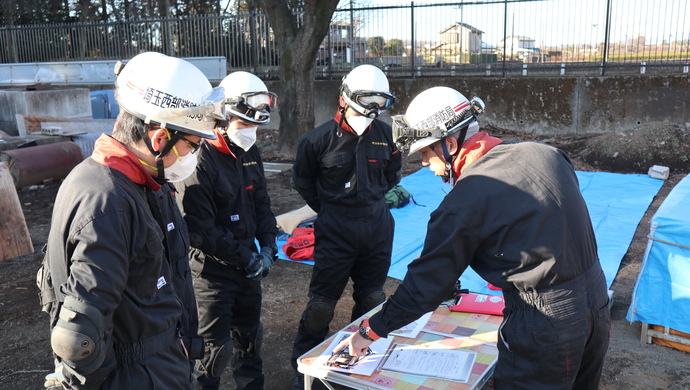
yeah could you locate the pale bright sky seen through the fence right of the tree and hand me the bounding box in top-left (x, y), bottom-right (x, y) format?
top-left (332, 0), bottom-right (690, 46)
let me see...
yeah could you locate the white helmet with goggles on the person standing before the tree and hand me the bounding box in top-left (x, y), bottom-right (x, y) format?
top-left (340, 65), bottom-right (395, 118)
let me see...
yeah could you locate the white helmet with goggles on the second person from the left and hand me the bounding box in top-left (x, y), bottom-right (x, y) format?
top-left (219, 71), bottom-right (278, 125)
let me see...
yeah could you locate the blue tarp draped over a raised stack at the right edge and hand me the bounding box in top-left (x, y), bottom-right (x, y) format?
top-left (626, 176), bottom-right (690, 333)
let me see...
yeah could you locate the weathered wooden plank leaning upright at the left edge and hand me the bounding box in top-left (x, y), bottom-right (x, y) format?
top-left (0, 162), bottom-right (34, 261)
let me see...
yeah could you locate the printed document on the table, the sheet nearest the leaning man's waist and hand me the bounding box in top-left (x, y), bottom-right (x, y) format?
top-left (379, 344), bottom-right (477, 383)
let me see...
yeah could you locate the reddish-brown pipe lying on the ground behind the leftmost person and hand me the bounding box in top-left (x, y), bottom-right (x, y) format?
top-left (0, 142), bottom-right (84, 189)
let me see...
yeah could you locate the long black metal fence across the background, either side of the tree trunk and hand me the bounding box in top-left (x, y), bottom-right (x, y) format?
top-left (0, 0), bottom-right (690, 78)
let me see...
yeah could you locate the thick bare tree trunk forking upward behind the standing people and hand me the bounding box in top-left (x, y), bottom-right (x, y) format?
top-left (257, 0), bottom-right (338, 153)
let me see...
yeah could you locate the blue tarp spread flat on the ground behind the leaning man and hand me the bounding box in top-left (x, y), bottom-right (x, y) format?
top-left (278, 168), bottom-right (663, 294)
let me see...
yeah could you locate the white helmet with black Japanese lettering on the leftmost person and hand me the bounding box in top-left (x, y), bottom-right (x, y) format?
top-left (115, 52), bottom-right (219, 139)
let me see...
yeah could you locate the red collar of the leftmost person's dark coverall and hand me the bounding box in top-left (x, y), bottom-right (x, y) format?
top-left (91, 134), bottom-right (161, 191)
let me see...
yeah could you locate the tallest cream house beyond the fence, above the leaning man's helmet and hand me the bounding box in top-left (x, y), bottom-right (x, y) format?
top-left (430, 22), bottom-right (484, 62)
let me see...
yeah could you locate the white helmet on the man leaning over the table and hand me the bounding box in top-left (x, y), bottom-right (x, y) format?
top-left (393, 87), bottom-right (484, 154)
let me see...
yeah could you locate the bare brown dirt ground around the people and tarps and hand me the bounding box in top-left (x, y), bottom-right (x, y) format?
top-left (0, 124), bottom-right (690, 390)
